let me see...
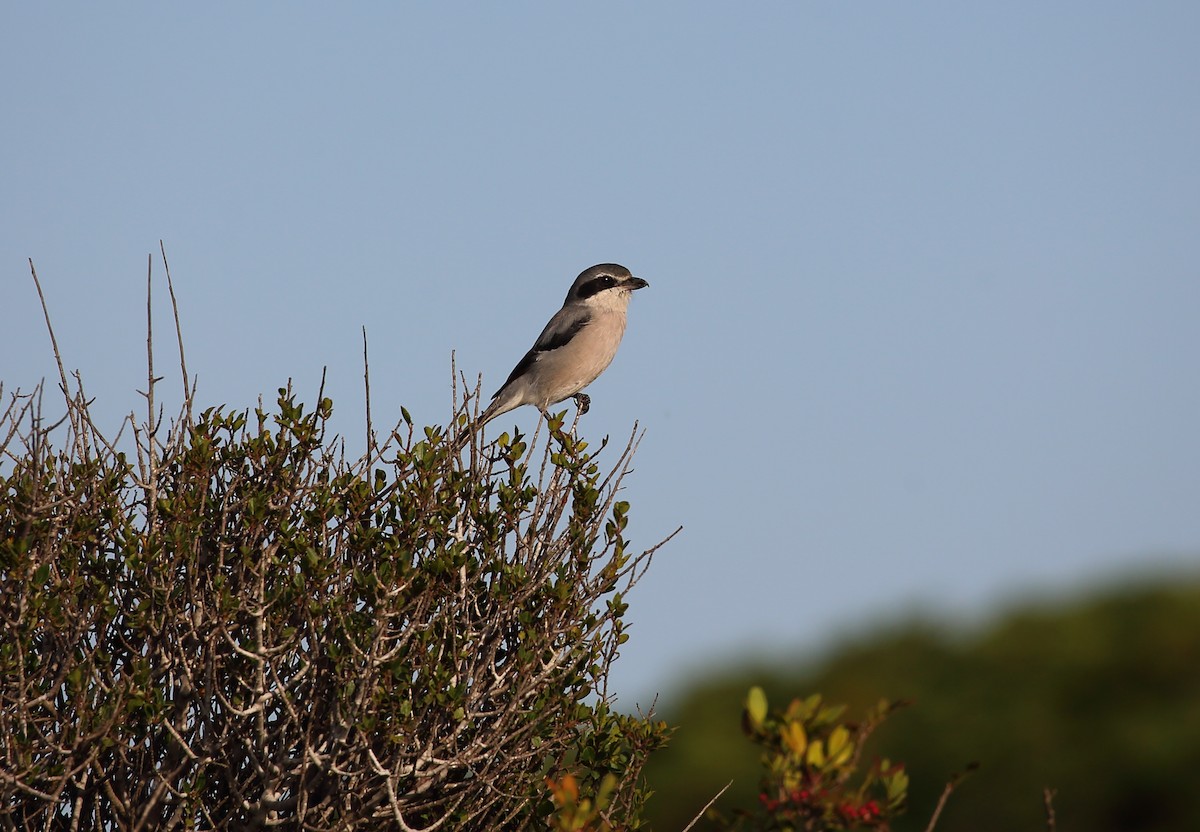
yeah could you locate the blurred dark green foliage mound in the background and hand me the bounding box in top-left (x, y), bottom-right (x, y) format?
top-left (647, 577), bottom-right (1200, 832)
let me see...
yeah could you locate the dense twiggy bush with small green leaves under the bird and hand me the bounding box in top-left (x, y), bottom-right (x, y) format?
top-left (0, 338), bottom-right (665, 830)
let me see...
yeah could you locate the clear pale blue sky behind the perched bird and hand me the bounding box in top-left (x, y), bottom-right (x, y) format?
top-left (0, 1), bottom-right (1200, 706)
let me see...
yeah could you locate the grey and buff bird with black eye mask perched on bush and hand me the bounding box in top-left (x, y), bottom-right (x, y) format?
top-left (460, 263), bottom-right (649, 444)
